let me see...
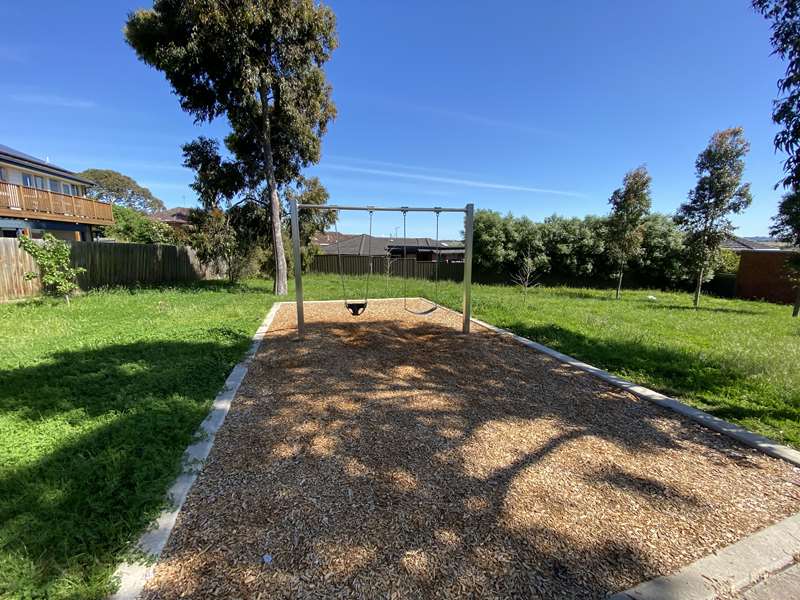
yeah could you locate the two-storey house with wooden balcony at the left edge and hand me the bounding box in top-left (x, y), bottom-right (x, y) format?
top-left (0, 144), bottom-right (114, 241)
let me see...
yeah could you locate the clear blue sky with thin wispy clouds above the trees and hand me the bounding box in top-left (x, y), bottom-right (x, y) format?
top-left (0, 0), bottom-right (784, 237)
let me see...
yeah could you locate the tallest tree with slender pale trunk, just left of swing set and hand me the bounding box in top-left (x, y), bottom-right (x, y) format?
top-left (125, 0), bottom-right (337, 294)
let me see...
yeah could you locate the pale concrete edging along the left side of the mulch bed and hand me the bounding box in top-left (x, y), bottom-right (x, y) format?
top-left (110, 302), bottom-right (287, 600)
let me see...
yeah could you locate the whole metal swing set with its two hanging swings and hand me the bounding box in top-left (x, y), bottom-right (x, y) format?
top-left (291, 200), bottom-right (474, 336)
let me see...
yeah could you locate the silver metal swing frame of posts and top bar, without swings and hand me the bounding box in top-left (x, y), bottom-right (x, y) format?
top-left (290, 199), bottom-right (475, 336)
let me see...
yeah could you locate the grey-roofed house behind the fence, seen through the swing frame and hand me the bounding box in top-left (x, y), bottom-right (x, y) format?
top-left (314, 233), bottom-right (464, 262)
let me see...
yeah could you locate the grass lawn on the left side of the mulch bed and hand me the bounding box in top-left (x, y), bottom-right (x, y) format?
top-left (0, 282), bottom-right (272, 599)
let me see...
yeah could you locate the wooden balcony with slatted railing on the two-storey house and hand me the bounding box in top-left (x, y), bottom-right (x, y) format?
top-left (0, 181), bottom-right (114, 225)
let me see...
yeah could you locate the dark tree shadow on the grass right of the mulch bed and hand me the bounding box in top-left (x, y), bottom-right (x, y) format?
top-left (506, 322), bottom-right (746, 395)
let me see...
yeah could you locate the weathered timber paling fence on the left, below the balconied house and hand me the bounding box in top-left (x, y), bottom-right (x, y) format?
top-left (0, 238), bottom-right (217, 302)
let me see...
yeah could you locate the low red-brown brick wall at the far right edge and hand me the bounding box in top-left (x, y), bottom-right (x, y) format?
top-left (736, 251), bottom-right (795, 304)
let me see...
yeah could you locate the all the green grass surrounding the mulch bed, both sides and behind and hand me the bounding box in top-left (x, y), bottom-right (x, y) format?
top-left (0, 276), bottom-right (800, 598)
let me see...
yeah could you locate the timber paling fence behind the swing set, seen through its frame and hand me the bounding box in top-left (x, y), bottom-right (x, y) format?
top-left (309, 254), bottom-right (464, 281)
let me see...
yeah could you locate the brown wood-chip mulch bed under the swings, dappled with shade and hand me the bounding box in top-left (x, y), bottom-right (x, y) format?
top-left (144, 301), bottom-right (800, 599)
